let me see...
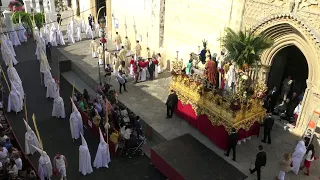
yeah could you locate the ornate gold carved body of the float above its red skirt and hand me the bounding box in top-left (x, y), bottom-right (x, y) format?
top-left (169, 74), bottom-right (266, 133)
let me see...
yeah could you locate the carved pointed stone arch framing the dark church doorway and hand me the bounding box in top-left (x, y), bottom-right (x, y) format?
top-left (252, 14), bottom-right (320, 129)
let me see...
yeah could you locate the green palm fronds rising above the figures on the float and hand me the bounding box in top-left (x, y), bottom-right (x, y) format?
top-left (222, 28), bottom-right (273, 67)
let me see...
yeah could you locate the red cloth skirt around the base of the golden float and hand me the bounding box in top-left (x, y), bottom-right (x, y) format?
top-left (176, 100), bottom-right (260, 149)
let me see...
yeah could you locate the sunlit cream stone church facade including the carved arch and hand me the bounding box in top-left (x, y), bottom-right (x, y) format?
top-left (108, 0), bottom-right (320, 129)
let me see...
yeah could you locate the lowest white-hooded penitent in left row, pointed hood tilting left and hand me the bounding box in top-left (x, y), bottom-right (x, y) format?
top-left (32, 145), bottom-right (52, 180)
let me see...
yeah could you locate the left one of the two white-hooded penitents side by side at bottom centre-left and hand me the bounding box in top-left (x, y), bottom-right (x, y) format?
top-left (79, 133), bottom-right (93, 176)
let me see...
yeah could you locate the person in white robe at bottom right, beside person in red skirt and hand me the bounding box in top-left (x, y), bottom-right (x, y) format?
top-left (292, 139), bottom-right (307, 174)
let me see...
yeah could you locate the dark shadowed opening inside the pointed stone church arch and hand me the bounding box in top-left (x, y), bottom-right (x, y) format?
top-left (267, 46), bottom-right (309, 97)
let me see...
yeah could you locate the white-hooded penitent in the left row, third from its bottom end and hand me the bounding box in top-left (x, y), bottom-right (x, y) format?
top-left (7, 85), bottom-right (23, 113)
